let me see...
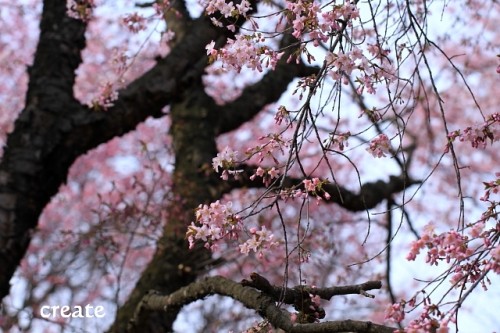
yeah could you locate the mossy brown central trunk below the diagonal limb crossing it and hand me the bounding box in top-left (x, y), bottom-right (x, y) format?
top-left (110, 85), bottom-right (221, 333)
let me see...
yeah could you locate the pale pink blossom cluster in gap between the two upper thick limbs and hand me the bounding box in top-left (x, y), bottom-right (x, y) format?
top-left (206, 33), bottom-right (283, 72)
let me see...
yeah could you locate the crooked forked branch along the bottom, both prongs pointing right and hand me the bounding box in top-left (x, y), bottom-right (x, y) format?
top-left (129, 273), bottom-right (395, 333)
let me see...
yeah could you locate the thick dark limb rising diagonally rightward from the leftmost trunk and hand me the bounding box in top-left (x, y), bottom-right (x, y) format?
top-left (64, 10), bottom-right (258, 160)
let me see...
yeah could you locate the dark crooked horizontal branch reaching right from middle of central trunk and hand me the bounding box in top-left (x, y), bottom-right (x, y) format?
top-left (221, 165), bottom-right (421, 212)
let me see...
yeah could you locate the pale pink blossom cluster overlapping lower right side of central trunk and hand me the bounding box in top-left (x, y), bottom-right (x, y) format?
top-left (186, 200), bottom-right (242, 251)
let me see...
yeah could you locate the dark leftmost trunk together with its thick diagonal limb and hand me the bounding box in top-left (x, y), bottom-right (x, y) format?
top-left (0, 8), bottom-right (229, 298)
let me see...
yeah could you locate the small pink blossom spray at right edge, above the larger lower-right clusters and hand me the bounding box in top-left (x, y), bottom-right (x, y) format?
top-left (448, 113), bottom-right (500, 149)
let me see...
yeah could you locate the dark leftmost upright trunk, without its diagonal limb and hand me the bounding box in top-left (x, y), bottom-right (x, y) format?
top-left (0, 0), bottom-right (85, 298)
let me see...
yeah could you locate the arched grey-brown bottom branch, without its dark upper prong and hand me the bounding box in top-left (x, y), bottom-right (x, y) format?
top-left (129, 276), bottom-right (394, 333)
